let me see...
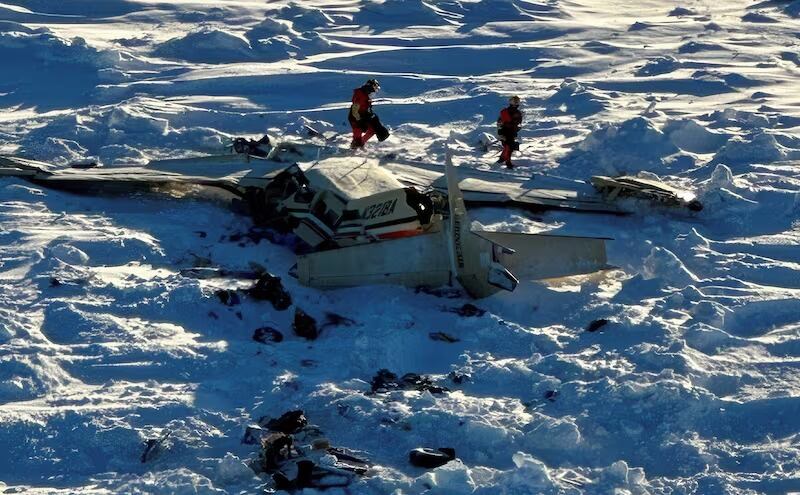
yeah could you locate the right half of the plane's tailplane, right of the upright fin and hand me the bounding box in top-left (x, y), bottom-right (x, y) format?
top-left (474, 231), bottom-right (610, 280)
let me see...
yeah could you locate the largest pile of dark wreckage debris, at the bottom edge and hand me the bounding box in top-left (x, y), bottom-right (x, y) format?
top-left (242, 410), bottom-right (371, 492)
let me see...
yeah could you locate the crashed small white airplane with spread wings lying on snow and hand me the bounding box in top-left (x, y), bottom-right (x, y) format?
top-left (0, 139), bottom-right (700, 298)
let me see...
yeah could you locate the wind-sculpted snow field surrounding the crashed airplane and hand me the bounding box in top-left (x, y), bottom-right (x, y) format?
top-left (0, 0), bottom-right (800, 495)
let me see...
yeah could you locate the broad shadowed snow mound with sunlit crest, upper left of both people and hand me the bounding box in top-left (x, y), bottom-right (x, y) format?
top-left (153, 27), bottom-right (253, 64)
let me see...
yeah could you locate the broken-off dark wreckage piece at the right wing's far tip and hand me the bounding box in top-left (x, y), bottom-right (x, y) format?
top-left (591, 175), bottom-right (703, 212)
